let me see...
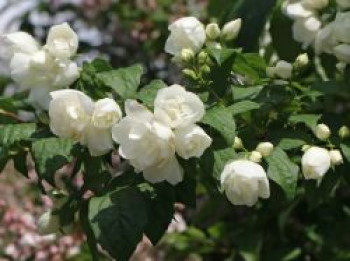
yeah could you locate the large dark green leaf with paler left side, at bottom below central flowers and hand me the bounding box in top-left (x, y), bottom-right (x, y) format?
top-left (89, 187), bottom-right (147, 261)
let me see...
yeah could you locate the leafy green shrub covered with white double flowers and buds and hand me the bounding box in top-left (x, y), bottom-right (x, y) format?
top-left (0, 1), bottom-right (350, 261)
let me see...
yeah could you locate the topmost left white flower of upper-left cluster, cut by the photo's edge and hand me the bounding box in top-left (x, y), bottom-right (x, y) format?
top-left (0, 32), bottom-right (40, 61)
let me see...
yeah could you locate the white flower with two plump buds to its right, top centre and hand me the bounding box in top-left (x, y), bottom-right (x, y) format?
top-left (165, 17), bottom-right (242, 57)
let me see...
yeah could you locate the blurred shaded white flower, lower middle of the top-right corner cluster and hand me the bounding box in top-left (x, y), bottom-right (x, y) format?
top-left (315, 23), bottom-right (337, 54)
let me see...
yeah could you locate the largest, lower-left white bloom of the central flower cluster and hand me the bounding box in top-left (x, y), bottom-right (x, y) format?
top-left (112, 100), bottom-right (183, 185)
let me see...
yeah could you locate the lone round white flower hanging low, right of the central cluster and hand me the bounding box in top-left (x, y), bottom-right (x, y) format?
top-left (220, 160), bottom-right (270, 206)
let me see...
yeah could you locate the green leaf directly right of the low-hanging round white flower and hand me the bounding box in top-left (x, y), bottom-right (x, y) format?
top-left (266, 148), bottom-right (299, 200)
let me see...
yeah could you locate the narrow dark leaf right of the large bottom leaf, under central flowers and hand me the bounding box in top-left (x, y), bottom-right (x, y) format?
top-left (145, 183), bottom-right (175, 245)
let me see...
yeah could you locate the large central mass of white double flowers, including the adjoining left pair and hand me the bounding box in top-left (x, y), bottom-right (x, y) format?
top-left (49, 85), bottom-right (212, 184)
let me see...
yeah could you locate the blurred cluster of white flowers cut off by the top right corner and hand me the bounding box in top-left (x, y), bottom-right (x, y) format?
top-left (283, 0), bottom-right (350, 63)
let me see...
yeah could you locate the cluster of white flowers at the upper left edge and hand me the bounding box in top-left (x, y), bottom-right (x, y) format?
top-left (0, 23), bottom-right (79, 109)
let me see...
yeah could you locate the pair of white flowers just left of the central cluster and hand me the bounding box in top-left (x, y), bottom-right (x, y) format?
top-left (49, 89), bottom-right (122, 156)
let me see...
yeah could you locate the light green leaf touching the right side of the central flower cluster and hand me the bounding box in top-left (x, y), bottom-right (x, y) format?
top-left (202, 105), bottom-right (236, 145)
